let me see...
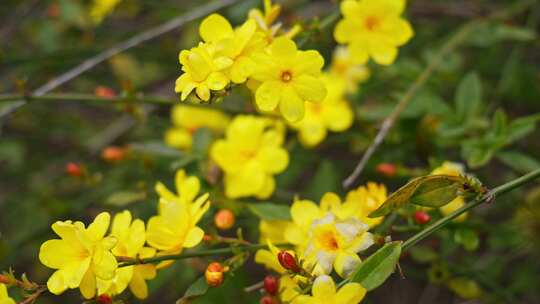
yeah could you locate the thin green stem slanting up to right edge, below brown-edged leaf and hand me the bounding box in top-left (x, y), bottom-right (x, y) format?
top-left (402, 169), bottom-right (540, 250)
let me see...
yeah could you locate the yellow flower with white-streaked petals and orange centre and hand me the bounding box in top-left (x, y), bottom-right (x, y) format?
top-left (285, 193), bottom-right (373, 277)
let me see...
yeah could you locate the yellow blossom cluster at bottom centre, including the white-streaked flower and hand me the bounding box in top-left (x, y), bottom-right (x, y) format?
top-left (255, 182), bottom-right (386, 303)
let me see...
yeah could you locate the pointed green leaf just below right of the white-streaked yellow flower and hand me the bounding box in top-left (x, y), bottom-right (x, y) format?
top-left (350, 242), bottom-right (401, 291)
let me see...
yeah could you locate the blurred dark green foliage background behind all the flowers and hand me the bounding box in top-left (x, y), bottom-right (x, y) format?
top-left (0, 0), bottom-right (540, 303)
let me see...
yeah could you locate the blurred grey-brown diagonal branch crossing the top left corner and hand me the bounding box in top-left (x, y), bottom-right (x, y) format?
top-left (0, 0), bottom-right (238, 117)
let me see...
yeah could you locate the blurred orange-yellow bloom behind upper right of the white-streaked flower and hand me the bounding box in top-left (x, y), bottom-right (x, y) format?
top-left (342, 182), bottom-right (387, 228)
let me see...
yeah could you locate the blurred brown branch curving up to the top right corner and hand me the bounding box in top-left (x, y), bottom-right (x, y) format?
top-left (343, 0), bottom-right (535, 188)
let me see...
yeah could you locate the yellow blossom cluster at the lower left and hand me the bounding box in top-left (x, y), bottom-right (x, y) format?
top-left (38, 171), bottom-right (210, 299)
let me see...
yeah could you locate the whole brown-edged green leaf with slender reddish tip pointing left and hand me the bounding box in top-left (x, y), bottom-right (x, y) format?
top-left (368, 175), bottom-right (466, 218)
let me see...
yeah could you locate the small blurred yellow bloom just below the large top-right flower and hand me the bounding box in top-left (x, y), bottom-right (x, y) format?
top-left (329, 46), bottom-right (369, 93)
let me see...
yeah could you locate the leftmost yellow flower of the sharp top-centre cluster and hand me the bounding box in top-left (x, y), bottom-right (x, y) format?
top-left (174, 43), bottom-right (233, 101)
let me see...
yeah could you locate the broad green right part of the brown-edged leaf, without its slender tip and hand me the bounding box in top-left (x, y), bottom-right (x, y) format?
top-left (410, 175), bottom-right (465, 208)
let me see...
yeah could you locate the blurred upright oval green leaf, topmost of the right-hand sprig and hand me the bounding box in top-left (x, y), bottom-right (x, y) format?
top-left (455, 72), bottom-right (482, 122)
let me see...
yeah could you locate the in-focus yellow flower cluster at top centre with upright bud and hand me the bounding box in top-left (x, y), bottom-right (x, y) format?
top-left (175, 1), bottom-right (326, 122)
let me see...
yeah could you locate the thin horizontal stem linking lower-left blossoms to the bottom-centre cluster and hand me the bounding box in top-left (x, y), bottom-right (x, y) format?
top-left (117, 244), bottom-right (290, 267)
